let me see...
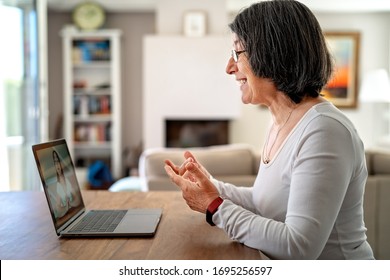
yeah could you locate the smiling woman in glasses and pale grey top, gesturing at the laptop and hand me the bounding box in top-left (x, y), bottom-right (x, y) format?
top-left (165, 0), bottom-right (374, 259)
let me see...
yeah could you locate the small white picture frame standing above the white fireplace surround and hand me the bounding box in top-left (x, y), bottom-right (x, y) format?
top-left (183, 11), bottom-right (206, 37)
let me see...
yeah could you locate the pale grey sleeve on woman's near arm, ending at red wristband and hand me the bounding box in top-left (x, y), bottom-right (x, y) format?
top-left (213, 116), bottom-right (361, 259)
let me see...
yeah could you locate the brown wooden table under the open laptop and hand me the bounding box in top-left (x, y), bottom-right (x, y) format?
top-left (0, 191), bottom-right (266, 260)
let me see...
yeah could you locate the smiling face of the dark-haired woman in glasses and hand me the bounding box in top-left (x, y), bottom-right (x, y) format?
top-left (226, 34), bottom-right (276, 105)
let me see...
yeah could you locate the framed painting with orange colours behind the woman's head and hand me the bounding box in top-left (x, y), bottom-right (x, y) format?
top-left (321, 32), bottom-right (360, 108)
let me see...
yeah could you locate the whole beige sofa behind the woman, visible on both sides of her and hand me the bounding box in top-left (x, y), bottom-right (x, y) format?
top-left (135, 144), bottom-right (390, 259)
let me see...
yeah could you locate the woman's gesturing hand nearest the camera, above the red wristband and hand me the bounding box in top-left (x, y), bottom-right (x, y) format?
top-left (165, 162), bottom-right (219, 213)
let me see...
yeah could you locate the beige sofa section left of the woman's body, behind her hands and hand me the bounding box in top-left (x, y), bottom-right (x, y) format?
top-left (139, 144), bottom-right (260, 191)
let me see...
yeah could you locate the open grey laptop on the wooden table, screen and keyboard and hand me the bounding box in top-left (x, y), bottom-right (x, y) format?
top-left (32, 139), bottom-right (162, 237)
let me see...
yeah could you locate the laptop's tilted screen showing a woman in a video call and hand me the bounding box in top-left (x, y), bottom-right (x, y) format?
top-left (33, 139), bottom-right (85, 233)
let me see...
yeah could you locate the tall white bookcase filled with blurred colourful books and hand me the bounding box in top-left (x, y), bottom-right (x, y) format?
top-left (61, 28), bottom-right (122, 179)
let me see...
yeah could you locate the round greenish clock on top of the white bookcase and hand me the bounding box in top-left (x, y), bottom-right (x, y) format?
top-left (72, 1), bottom-right (106, 30)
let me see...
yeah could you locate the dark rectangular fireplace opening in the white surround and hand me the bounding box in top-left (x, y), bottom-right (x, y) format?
top-left (165, 120), bottom-right (229, 148)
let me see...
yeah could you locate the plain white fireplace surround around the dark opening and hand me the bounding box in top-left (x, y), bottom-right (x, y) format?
top-left (143, 36), bottom-right (241, 148)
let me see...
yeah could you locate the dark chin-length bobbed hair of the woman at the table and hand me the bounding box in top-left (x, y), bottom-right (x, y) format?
top-left (229, 0), bottom-right (333, 103)
